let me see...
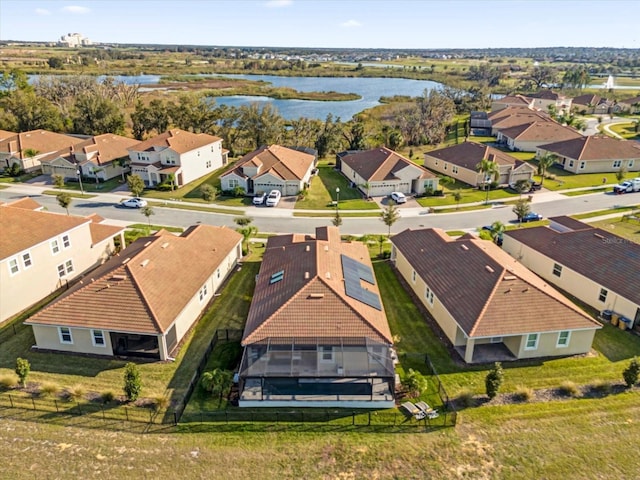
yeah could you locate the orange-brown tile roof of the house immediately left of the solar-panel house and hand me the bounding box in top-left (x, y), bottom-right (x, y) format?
top-left (29, 225), bottom-right (242, 334)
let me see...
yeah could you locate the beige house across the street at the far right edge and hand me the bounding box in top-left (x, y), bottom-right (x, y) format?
top-left (537, 135), bottom-right (640, 173)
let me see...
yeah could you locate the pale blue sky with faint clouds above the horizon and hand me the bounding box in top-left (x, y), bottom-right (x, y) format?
top-left (0, 0), bottom-right (640, 49)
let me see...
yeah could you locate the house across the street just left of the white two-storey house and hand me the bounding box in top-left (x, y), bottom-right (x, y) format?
top-left (40, 133), bottom-right (140, 182)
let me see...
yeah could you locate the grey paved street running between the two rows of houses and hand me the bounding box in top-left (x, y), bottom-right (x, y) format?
top-left (0, 185), bottom-right (640, 235)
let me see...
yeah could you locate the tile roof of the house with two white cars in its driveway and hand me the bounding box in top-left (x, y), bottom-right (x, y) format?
top-left (221, 145), bottom-right (316, 180)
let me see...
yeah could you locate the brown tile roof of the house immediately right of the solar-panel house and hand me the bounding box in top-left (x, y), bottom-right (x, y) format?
top-left (391, 229), bottom-right (600, 337)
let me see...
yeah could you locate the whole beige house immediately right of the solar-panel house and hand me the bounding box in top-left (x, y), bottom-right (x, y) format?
top-left (391, 229), bottom-right (601, 363)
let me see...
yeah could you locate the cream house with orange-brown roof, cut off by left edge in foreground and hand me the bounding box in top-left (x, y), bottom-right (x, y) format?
top-left (0, 197), bottom-right (124, 322)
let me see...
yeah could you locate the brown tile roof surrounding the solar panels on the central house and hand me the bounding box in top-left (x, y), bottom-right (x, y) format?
top-left (242, 227), bottom-right (393, 345)
